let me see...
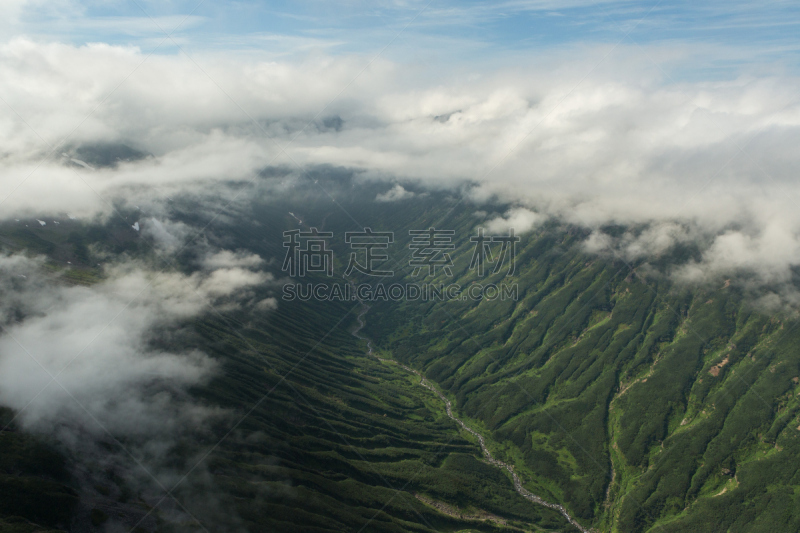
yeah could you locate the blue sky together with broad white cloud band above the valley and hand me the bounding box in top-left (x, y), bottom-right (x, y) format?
top-left (0, 0), bottom-right (800, 282)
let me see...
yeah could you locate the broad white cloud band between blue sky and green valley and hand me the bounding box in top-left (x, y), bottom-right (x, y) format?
top-left (0, 39), bottom-right (800, 288)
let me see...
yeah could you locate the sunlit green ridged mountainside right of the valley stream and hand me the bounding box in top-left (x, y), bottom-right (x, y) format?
top-left (367, 218), bottom-right (800, 531)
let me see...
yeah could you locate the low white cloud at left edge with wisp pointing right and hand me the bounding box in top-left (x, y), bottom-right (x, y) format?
top-left (0, 255), bottom-right (274, 438)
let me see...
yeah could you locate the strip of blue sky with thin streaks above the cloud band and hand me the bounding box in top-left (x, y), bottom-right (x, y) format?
top-left (11, 0), bottom-right (800, 74)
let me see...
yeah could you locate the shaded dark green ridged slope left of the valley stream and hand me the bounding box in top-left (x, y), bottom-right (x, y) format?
top-left (180, 296), bottom-right (576, 531)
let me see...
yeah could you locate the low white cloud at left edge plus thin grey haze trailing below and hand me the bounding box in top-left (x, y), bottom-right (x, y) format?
top-left (0, 249), bottom-right (277, 522)
